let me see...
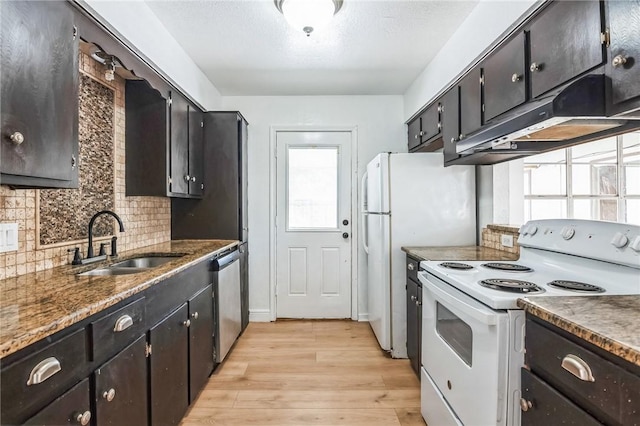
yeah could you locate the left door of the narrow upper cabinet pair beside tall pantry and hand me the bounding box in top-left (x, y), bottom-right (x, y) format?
top-left (169, 92), bottom-right (190, 194)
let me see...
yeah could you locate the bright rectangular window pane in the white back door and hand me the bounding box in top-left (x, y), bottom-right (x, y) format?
top-left (287, 147), bottom-right (339, 229)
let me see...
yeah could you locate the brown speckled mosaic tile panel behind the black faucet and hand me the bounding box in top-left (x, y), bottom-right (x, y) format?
top-left (39, 74), bottom-right (115, 245)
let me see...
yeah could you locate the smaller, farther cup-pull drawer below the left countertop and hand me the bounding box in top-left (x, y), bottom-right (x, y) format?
top-left (91, 297), bottom-right (145, 361)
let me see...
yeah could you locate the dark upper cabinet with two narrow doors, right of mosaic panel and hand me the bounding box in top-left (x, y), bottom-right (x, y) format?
top-left (125, 80), bottom-right (204, 198)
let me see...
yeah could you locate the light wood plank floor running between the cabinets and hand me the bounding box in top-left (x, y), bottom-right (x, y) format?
top-left (182, 320), bottom-right (425, 426)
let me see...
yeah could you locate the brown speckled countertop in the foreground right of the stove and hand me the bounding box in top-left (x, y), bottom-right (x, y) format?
top-left (518, 295), bottom-right (640, 366)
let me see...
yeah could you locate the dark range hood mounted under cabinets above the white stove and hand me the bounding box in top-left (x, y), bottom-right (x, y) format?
top-left (451, 74), bottom-right (640, 164)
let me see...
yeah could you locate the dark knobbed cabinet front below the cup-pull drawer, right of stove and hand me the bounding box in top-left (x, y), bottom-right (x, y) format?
top-left (521, 368), bottom-right (600, 426)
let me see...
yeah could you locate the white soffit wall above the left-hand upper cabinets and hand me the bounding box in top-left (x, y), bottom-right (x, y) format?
top-left (78, 0), bottom-right (221, 110)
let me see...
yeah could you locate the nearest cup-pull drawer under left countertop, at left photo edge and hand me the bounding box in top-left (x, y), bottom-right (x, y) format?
top-left (1, 328), bottom-right (87, 424)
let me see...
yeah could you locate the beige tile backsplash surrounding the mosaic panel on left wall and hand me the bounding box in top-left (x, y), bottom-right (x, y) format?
top-left (0, 54), bottom-right (171, 279)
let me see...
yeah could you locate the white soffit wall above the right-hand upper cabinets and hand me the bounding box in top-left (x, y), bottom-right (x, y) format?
top-left (404, 0), bottom-right (538, 121)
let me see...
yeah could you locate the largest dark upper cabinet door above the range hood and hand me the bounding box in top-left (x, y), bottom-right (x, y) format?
top-left (529, 0), bottom-right (603, 97)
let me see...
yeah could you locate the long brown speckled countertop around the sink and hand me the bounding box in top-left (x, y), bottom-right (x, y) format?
top-left (0, 240), bottom-right (238, 358)
